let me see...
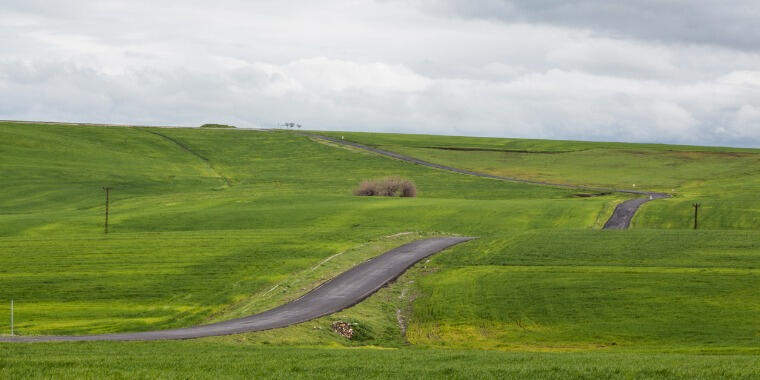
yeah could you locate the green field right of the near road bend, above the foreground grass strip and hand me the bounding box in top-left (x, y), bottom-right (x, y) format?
top-left (407, 230), bottom-right (760, 354)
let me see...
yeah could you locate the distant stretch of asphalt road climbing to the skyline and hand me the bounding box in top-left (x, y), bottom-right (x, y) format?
top-left (303, 133), bottom-right (670, 230)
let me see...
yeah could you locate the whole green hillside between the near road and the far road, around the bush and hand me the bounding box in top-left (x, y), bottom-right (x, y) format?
top-left (0, 125), bottom-right (604, 334)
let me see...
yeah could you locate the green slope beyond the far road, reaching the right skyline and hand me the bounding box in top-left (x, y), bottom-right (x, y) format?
top-left (318, 132), bottom-right (760, 229)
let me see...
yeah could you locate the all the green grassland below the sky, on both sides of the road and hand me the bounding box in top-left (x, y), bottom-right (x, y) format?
top-left (0, 123), bottom-right (760, 378)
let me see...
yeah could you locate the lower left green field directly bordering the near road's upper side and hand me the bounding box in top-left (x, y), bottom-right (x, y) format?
top-left (0, 229), bottom-right (382, 335)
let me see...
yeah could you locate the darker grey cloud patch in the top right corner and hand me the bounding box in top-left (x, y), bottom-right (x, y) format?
top-left (423, 0), bottom-right (760, 51)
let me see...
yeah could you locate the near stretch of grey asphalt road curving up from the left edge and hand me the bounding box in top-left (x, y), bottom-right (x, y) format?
top-left (0, 237), bottom-right (473, 342)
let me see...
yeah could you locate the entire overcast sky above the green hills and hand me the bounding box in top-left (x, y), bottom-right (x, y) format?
top-left (0, 0), bottom-right (760, 147)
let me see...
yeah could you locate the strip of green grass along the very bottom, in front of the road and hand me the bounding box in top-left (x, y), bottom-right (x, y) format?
top-left (0, 339), bottom-right (760, 379)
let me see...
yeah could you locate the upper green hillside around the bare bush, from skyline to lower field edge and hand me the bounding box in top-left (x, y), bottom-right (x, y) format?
top-left (0, 124), bottom-right (600, 236)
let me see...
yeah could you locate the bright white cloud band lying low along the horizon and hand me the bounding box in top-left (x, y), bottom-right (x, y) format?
top-left (0, 58), bottom-right (760, 146)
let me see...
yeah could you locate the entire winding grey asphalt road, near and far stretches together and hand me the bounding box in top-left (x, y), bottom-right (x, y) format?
top-left (0, 126), bottom-right (670, 342)
